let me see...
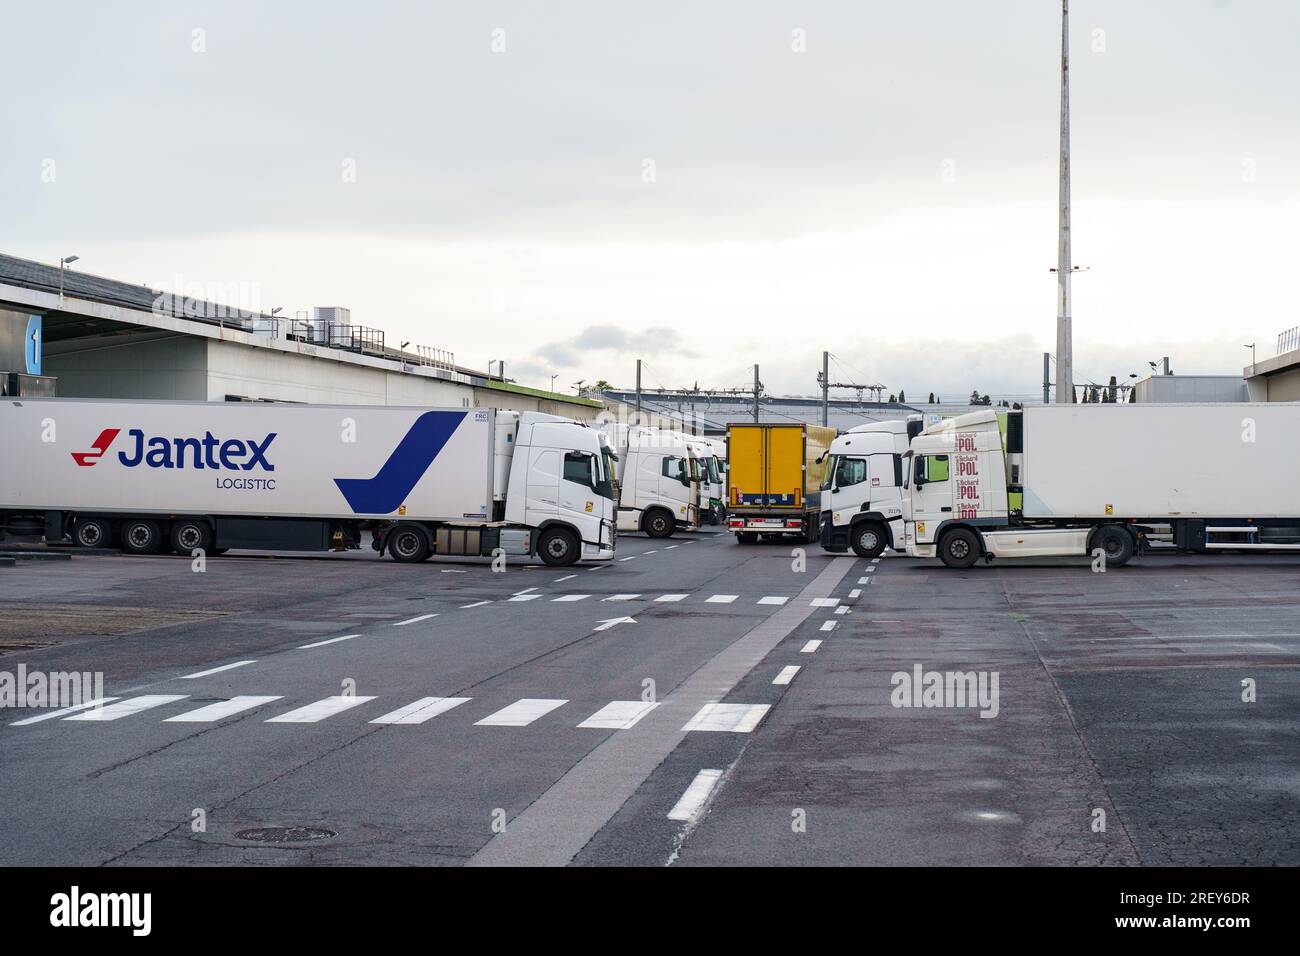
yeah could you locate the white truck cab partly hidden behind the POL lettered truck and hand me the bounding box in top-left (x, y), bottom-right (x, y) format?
top-left (822, 415), bottom-right (922, 558)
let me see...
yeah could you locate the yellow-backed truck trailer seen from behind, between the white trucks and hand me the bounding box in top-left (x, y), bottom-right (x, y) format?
top-left (727, 423), bottom-right (836, 545)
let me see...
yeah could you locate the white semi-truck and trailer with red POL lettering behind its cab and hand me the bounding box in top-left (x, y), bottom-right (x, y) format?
top-left (904, 403), bottom-right (1300, 568)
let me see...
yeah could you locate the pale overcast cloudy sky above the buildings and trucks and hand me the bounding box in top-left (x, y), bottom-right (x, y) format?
top-left (0, 0), bottom-right (1300, 397)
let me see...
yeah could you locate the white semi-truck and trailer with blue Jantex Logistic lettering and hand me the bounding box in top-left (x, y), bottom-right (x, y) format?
top-left (0, 399), bottom-right (615, 564)
